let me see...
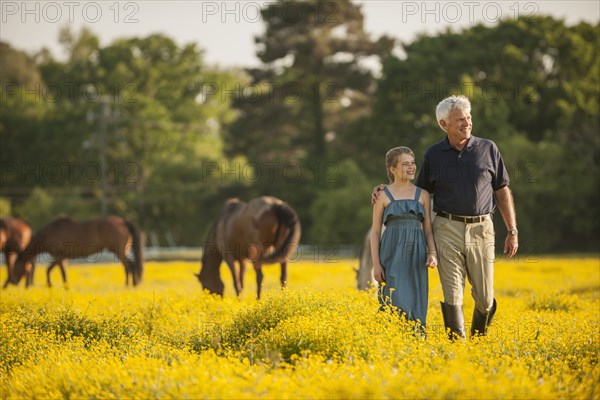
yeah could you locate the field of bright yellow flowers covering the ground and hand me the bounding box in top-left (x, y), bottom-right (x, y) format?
top-left (0, 256), bottom-right (600, 399)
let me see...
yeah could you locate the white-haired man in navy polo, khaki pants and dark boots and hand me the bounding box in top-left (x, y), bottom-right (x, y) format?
top-left (376, 96), bottom-right (518, 339)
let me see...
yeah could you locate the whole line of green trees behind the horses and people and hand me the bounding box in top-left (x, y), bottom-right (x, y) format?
top-left (0, 0), bottom-right (600, 253)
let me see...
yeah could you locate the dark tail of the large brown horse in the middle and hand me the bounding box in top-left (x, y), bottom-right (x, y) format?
top-left (261, 202), bottom-right (302, 264)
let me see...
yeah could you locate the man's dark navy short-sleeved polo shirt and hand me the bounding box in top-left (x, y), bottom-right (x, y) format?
top-left (415, 135), bottom-right (509, 216)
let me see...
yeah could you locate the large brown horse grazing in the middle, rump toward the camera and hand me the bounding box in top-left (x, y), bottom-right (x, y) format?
top-left (196, 196), bottom-right (301, 299)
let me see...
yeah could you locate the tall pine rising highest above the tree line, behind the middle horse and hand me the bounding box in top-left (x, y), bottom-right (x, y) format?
top-left (225, 0), bottom-right (393, 239)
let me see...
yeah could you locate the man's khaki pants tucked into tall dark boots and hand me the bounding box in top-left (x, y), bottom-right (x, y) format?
top-left (433, 216), bottom-right (495, 313)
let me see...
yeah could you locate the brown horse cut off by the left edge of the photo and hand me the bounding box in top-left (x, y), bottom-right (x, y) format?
top-left (0, 217), bottom-right (33, 288)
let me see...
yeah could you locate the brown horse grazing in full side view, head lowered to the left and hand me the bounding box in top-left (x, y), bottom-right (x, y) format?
top-left (10, 216), bottom-right (144, 287)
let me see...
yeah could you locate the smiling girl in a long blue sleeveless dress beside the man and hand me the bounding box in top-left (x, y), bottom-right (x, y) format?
top-left (371, 147), bottom-right (437, 326)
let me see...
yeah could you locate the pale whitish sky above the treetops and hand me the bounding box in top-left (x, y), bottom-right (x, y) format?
top-left (0, 0), bottom-right (600, 67)
